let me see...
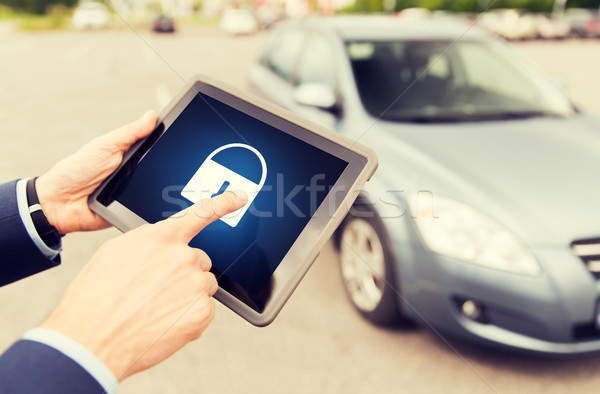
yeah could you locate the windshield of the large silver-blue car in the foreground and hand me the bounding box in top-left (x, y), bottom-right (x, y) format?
top-left (346, 40), bottom-right (574, 122)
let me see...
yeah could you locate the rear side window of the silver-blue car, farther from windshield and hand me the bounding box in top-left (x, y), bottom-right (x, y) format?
top-left (267, 30), bottom-right (306, 79)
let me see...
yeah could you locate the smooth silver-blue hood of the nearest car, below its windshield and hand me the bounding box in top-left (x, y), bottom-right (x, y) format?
top-left (361, 115), bottom-right (600, 245)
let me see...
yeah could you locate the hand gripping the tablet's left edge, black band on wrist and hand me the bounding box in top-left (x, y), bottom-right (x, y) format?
top-left (36, 111), bottom-right (156, 234)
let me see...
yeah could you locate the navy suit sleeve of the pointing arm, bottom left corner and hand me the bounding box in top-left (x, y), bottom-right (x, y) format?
top-left (0, 340), bottom-right (105, 394)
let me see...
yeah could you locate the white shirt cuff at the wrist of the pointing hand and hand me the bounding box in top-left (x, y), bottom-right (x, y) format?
top-left (23, 327), bottom-right (118, 394)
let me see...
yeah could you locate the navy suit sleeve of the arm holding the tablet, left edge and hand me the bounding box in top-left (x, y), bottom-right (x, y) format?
top-left (0, 181), bottom-right (60, 286)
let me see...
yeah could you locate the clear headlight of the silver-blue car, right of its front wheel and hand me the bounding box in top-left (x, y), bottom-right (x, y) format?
top-left (410, 195), bottom-right (541, 275)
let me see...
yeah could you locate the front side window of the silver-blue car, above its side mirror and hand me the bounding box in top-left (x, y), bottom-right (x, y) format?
top-left (295, 34), bottom-right (336, 89)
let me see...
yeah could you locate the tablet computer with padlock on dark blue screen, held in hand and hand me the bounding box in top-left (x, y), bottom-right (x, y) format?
top-left (89, 77), bottom-right (377, 326)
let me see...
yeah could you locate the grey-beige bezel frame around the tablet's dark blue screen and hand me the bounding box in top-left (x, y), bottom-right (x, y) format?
top-left (89, 76), bottom-right (377, 326)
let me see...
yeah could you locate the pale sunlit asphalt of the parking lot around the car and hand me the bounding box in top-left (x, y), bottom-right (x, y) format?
top-left (0, 26), bottom-right (600, 394)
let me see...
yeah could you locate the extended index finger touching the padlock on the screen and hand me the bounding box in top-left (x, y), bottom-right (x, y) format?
top-left (166, 191), bottom-right (248, 243)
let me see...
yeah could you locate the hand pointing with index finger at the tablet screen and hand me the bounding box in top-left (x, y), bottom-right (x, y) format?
top-left (42, 192), bottom-right (248, 381)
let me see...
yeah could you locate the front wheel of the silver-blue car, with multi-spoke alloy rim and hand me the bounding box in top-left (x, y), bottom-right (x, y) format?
top-left (338, 205), bottom-right (405, 325)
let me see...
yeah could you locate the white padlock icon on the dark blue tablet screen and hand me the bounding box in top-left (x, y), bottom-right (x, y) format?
top-left (181, 143), bottom-right (267, 227)
